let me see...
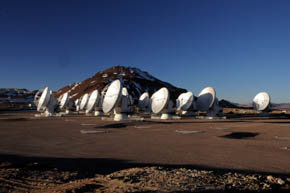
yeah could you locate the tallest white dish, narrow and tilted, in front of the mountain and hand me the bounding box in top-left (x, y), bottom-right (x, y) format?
top-left (102, 80), bottom-right (122, 113)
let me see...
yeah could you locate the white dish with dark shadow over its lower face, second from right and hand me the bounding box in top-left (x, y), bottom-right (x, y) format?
top-left (196, 87), bottom-right (216, 111)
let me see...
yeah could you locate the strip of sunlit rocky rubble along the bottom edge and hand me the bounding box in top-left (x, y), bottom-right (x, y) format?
top-left (0, 162), bottom-right (290, 193)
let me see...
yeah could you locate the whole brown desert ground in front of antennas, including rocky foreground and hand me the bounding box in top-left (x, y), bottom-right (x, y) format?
top-left (0, 112), bottom-right (290, 192)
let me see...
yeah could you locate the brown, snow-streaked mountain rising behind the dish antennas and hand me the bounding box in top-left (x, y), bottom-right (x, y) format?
top-left (55, 66), bottom-right (186, 101)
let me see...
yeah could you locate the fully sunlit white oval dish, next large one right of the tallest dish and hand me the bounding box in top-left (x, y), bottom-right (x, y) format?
top-left (151, 87), bottom-right (169, 114)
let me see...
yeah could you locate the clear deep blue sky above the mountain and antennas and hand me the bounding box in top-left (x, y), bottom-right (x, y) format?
top-left (0, 0), bottom-right (290, 103)
